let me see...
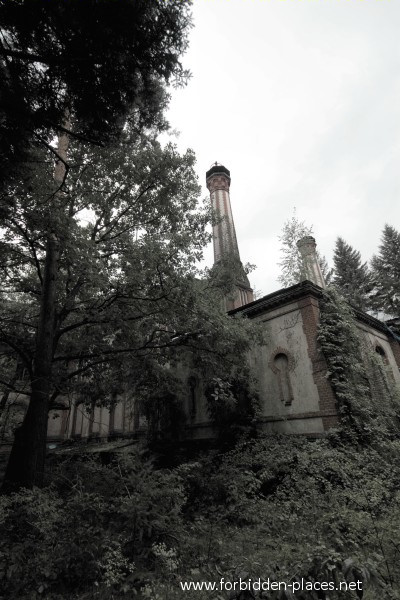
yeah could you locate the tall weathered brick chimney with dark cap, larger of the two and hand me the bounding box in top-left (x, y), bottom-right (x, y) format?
top-left (206, 163), bottom-right (254, 310)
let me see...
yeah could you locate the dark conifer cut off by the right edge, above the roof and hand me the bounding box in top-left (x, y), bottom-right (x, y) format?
top-left (371, 224), bottom-right (400, 317)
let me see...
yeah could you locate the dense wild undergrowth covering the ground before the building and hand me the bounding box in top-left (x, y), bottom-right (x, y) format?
top-left (0, 435), bottom-right (400, 600)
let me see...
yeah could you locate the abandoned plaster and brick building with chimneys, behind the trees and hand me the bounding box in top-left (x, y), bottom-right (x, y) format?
top-left (2, 164), bottom-right (400, 444)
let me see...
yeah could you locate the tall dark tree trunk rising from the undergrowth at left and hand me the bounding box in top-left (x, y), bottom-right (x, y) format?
top-left (2, 126), bottom-right (69, 493)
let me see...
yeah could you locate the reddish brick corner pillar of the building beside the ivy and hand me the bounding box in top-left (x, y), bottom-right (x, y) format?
top-left (298, 296), bottom-right (339, 431)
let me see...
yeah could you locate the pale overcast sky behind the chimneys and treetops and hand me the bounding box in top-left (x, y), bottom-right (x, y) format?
top-left (168, 0), bottom-right (400, 294)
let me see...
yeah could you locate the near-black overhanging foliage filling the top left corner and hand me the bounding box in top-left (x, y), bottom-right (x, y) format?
top-left (0, 0), bottom-right (191, 185)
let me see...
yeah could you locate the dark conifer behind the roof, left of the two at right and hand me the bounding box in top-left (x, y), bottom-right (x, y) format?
top-left (333, 237), bottom-right (371, 310)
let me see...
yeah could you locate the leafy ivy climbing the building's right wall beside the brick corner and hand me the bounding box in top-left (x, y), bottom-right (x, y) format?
top-left (318, 288), bottom-right (400, 443)
